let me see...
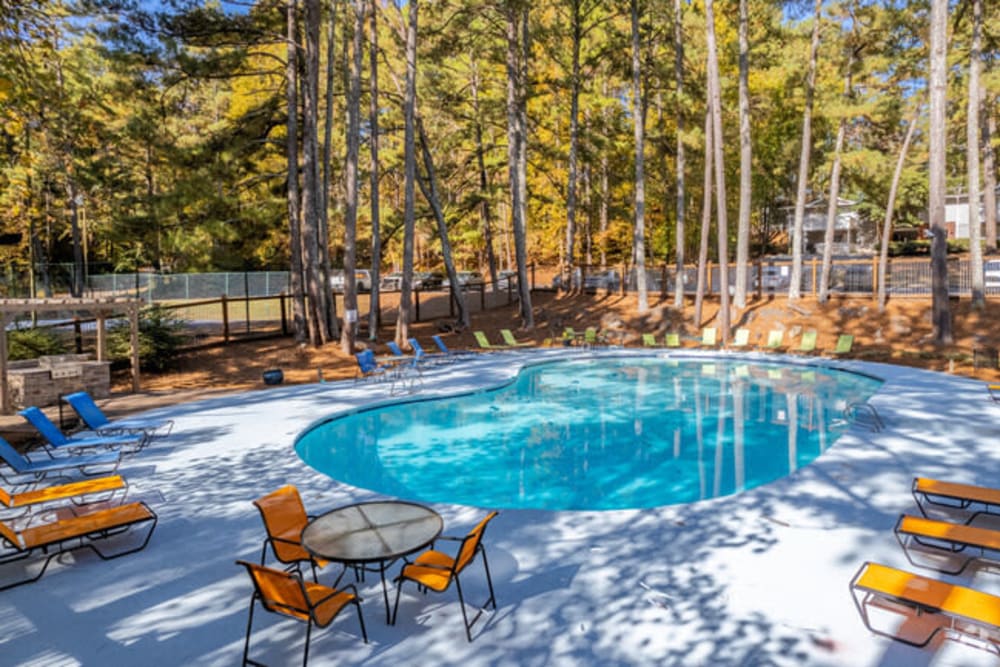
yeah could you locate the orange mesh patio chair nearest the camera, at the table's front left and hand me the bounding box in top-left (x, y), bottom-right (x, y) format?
top-left (236, 560), bottom-right (368, 667)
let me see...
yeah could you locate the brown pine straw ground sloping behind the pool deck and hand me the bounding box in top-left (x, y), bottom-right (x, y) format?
top-left (121, 292), bottom-right (1000, 396)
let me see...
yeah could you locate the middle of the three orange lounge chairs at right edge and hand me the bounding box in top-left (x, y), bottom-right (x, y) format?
top-left (893, 514), bottom-right (1000, 574)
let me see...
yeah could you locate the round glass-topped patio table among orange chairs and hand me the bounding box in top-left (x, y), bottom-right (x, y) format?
top-left (302, 500), bottom-right (444, 623)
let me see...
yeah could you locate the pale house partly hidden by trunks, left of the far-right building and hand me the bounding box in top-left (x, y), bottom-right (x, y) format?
top-left (783, 197), bottom-right (877, 255)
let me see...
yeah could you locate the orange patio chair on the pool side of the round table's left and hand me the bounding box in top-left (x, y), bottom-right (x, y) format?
top-left (253, 484), bottom-right (328, 581)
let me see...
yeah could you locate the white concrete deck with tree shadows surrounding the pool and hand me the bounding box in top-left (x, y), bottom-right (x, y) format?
top-left (0, 350), bottom-right (1000, 667)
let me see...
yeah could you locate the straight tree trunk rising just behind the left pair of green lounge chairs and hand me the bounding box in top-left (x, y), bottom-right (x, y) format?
top-left (506, 0), bottom-right (535, 329)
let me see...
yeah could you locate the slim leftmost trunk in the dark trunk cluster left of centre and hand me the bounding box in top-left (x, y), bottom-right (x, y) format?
top-left (285, 0), bottom-right (308, 343)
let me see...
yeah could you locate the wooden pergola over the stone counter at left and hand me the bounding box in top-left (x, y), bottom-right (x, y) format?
top-left (0, 298), bottom-right (142, 414)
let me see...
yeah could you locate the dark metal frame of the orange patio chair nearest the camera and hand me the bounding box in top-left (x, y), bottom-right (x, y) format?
top-left (236, 560), bottom-right (368, 667)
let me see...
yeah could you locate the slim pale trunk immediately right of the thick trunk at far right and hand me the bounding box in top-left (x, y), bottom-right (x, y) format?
top-left (965, 0), bottom-right (986, 310)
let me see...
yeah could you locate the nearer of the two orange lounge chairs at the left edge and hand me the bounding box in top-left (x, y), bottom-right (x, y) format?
top-left (0, 502), bottom-right (156, 590)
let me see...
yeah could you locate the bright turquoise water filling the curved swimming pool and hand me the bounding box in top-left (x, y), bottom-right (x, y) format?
top-left (296, 357), bottom-right (882, 510)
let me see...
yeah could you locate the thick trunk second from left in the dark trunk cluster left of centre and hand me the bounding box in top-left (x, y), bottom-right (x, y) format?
top-left (301, 0), bottom-right (330, 345)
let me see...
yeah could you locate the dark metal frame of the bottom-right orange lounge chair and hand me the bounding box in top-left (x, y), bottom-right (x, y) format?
top-left (850, 561), bottom-right (1000, 656)
